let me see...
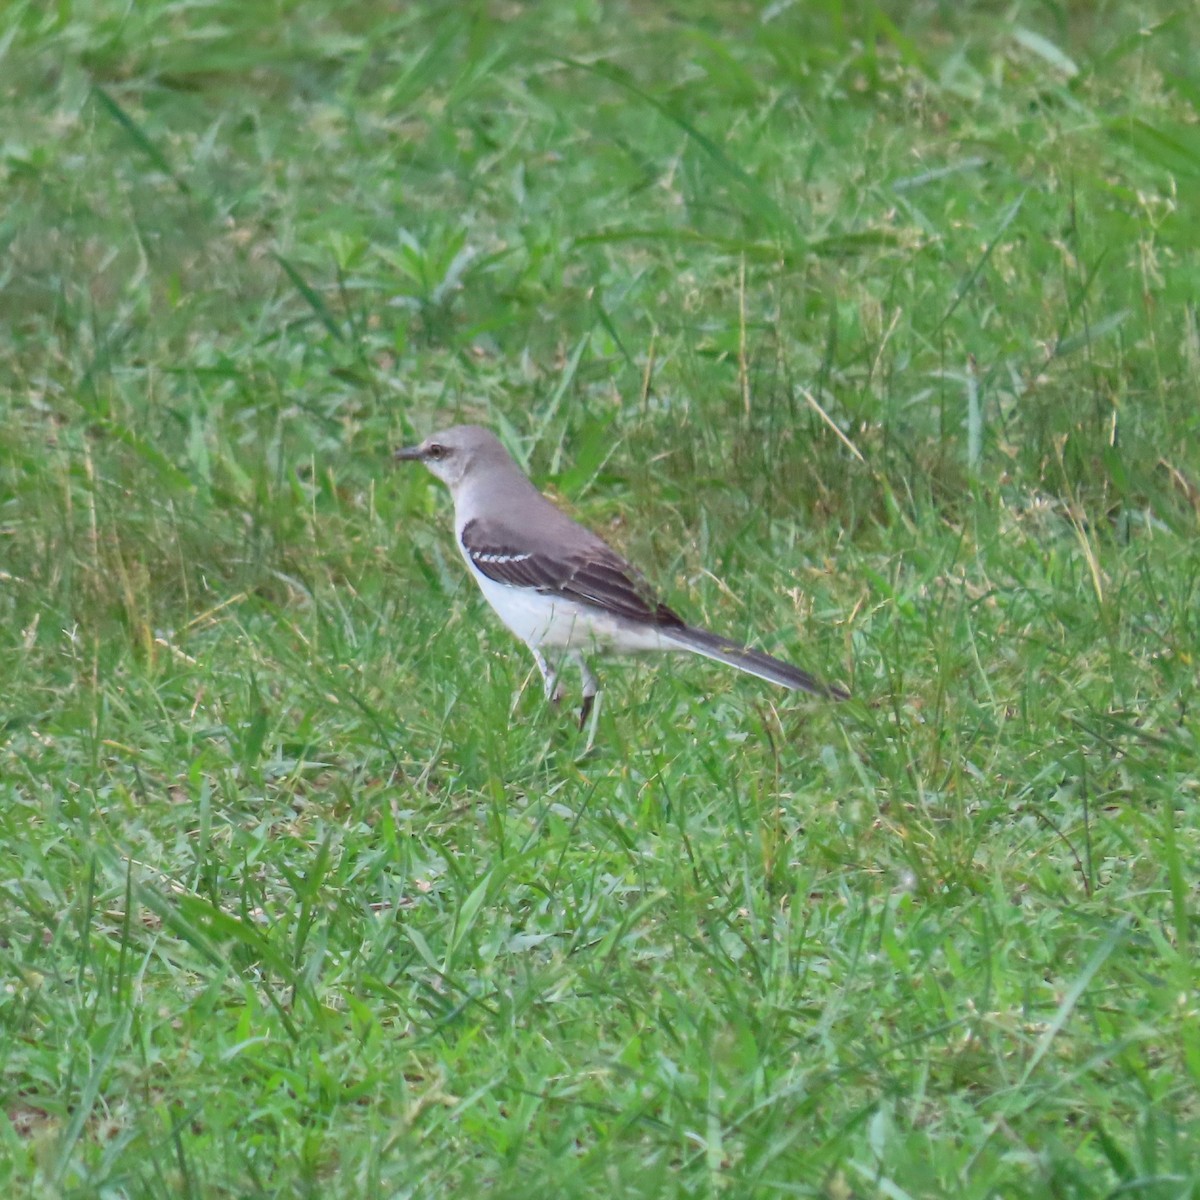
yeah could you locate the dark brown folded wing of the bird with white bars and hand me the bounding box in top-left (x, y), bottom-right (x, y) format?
top-left (462, 517), bottom-right (684, 625)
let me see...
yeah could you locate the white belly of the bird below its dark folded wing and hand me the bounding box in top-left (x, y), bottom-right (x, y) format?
top-left (467, 559), bottom-right (683, 654)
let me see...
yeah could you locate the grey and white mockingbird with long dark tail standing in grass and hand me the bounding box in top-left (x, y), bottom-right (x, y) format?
top-left (396, 425), bottom-right (850, 727)
